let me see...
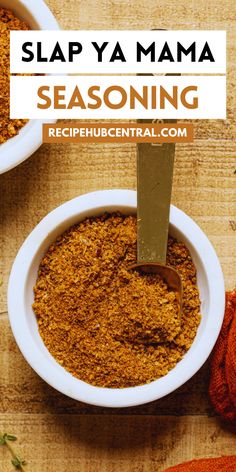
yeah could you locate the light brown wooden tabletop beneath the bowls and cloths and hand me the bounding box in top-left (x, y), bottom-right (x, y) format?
top-left (0, 0), bottom-right (236, 472)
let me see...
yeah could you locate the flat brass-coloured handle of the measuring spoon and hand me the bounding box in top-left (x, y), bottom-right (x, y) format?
top-left (137, 138), bottom-right (175, 264)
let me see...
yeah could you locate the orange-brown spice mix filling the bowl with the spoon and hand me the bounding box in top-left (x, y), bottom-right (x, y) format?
top-left (33, 213), bottom-right (200, 388)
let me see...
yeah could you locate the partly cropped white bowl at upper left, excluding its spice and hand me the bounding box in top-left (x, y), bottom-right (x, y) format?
top-left (0, 0), bottom-right (59, 174)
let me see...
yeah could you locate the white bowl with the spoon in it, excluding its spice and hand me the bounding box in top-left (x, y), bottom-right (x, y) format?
top-left (8, 190), bottom-right (225, 407)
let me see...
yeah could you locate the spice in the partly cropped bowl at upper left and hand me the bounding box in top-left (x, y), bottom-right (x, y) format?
top-left (0, 7), bottom-right (30, 144)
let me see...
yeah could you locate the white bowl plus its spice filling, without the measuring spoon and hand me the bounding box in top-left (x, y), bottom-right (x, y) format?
top-left (8, 190), bottom-right (225, 407)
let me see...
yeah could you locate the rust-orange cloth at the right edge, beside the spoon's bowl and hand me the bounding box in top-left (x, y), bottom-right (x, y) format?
top-left (209, 291), bottom-right (236, 424)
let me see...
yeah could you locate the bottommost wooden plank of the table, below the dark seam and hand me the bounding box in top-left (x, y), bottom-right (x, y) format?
top-left (0, 412), bottom-right (235, 472)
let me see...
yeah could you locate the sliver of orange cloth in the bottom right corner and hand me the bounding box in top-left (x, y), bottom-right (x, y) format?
top-left (164, 456), bottom-right (236, 472)
